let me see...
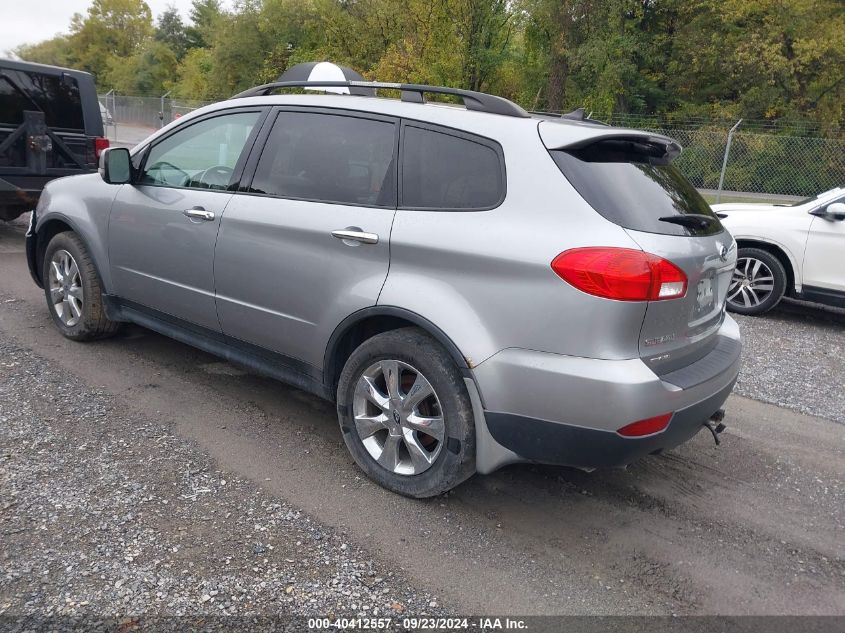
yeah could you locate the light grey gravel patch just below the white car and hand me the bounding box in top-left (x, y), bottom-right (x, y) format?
top-left (733, 301), bottom-right (845, 424)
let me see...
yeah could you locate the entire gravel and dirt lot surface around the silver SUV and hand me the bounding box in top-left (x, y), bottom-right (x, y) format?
top-left (0, 216), bottom-right (845, 615)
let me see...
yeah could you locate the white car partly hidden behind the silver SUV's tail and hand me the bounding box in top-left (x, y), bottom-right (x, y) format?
top-left (713, 187), bottom-right (845, 315)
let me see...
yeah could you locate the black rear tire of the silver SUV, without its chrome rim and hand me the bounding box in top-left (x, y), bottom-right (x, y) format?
top-left (337, 328), bottom-right (475, 498)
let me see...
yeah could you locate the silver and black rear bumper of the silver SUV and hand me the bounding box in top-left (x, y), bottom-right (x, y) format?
top-left (473, 317), bottom-right (741, 472)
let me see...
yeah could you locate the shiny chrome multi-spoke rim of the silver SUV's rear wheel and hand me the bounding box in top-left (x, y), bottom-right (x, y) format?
top-left (353, 360), bottom-right (446, 476)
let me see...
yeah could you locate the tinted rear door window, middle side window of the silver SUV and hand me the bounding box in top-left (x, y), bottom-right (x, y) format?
top-left (250, 112), bottom-right (396, 207)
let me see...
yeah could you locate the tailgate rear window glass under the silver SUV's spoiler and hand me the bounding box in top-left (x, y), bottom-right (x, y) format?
top-left (550, 140), bottom-right (723, 236)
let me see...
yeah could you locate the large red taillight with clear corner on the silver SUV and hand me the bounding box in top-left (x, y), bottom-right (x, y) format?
top-left (552, 246), bottom-right (687, 301)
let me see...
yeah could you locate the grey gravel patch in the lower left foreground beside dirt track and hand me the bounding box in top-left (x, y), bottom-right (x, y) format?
top-left (0, 340), bottom-right (444, 628)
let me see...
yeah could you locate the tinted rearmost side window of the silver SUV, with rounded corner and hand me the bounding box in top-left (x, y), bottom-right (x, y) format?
top-left (402, 125), bottom-right (505, 209)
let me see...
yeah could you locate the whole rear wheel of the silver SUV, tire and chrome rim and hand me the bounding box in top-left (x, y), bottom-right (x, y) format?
top-left (337, 328), bottom-right (475, 498)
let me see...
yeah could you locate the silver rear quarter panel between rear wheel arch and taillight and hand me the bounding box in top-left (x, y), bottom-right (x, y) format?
top-left (379, 121), bottom-right (645, 367)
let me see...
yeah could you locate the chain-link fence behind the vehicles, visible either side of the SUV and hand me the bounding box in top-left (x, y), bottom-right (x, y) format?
top-left (100, 93), bottom-right (845, 197)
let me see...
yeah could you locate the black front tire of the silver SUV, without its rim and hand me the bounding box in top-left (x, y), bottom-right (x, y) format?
top-left (41, 231), bottom-right (120, 341)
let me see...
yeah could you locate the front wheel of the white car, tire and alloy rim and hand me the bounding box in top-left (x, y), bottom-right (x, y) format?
top-left (728, 248), bottom-right (787, 316)
